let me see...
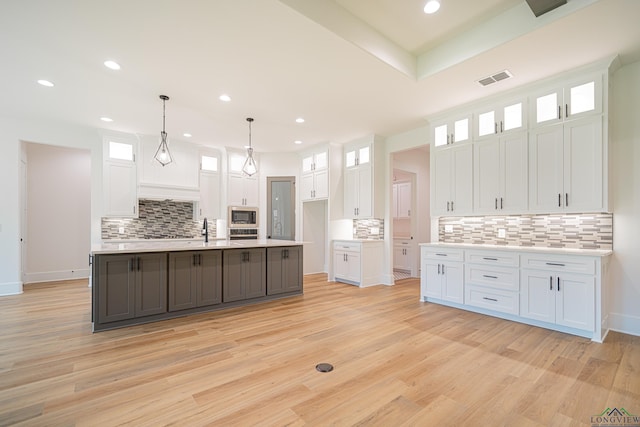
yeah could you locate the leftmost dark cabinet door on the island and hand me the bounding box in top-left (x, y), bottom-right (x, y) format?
top-left (94, 255), bottom-right (135, 323)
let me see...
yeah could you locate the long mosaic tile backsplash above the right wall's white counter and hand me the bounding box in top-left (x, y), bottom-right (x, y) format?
top-left (438, 213), bottom-right (613, 250)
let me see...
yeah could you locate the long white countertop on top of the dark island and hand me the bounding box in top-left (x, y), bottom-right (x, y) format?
top-left (91, 239), bottom-right (306, 255)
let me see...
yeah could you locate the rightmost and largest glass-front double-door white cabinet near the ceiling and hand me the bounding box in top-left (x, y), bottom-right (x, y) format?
top-left (530, 74), bottom-right (602, 127)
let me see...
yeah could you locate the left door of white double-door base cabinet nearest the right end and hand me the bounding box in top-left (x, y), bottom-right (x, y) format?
top-left (520, 270), bottom-right (556, 323)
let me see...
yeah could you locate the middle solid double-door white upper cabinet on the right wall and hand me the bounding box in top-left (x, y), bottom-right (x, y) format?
top-left (473, 131), bottom-right (528, 214)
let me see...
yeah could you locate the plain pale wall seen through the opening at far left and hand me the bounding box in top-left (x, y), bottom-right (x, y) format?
top-left (23, 143), bottom-right (91, 283)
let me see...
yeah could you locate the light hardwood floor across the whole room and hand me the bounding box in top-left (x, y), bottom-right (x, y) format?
top-left (0, 275), bottom-right (640, 426)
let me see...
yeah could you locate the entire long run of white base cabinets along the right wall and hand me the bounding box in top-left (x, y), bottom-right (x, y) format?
top-left (420, 244), bottom-right (610, 342)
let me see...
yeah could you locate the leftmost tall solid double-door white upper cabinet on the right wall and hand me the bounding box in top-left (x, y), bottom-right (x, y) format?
top-left (431, 144), bottom-right (473, 216)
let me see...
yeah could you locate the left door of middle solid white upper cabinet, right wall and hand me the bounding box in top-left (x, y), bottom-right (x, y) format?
top-left (473, 137), bottom-right (501, 213)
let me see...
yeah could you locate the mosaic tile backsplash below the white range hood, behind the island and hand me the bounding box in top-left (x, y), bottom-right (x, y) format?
top-left (102, 199), bottom-right (210, 240)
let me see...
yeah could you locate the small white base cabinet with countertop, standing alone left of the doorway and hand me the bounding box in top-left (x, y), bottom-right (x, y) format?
top-left (333, 240), bottom-right (384, 287)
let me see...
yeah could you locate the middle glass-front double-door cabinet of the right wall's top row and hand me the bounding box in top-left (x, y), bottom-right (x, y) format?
top-left (473, 99), bottom-right (527, 140)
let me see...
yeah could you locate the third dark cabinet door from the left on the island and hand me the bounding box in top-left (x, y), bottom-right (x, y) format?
top-left (169, 252), bottom-right (198, 311)
